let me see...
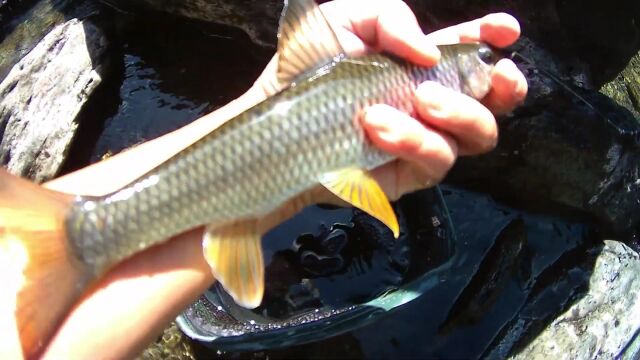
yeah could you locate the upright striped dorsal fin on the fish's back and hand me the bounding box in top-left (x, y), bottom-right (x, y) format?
top-left (278, 0), bottom-right (344, 85)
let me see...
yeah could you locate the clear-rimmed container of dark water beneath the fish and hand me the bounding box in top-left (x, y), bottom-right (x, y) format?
top-left (178, 189), bottom-right (455, 351)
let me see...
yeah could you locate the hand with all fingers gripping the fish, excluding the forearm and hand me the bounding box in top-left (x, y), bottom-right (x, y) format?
top-left (248, 0), bottom-right (527, 202)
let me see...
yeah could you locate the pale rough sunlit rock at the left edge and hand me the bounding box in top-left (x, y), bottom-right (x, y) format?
top-left (0, 19), bottom-right (107, 181)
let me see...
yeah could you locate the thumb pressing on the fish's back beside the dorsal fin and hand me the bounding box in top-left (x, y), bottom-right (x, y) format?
top-left (322, 0), bottom-right (440, 66)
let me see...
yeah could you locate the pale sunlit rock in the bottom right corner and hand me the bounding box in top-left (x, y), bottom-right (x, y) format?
top-left (504, 241), bottom-right (640, 360)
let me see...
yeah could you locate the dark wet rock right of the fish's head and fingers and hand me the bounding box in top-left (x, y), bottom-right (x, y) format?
top-left (448, 38), bottom-right (640, 241)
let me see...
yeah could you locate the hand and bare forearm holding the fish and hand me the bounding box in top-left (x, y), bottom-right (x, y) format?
top-left (0, 1), bottom-right (526, 358)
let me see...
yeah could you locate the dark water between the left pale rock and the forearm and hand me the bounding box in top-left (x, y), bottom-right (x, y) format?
top-left (63, 13), bottom-right (273, 172)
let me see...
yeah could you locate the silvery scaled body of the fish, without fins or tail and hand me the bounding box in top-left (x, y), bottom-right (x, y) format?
top-left (67, 44), bottom-right (496, 271)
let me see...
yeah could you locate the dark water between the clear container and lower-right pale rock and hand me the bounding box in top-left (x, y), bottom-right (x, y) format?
top-left (184, 186), bottom-right (597, 359)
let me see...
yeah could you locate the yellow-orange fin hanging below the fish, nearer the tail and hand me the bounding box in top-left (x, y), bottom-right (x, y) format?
top-left (202, 220), bottom-right (264, 309)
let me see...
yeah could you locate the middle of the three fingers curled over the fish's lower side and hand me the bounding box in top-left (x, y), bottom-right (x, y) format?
top-left (414, 81), bottom-right (498, 155)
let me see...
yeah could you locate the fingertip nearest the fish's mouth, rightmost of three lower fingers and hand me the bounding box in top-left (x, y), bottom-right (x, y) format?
top-left (482, 59), bottom-right (528, 114)
